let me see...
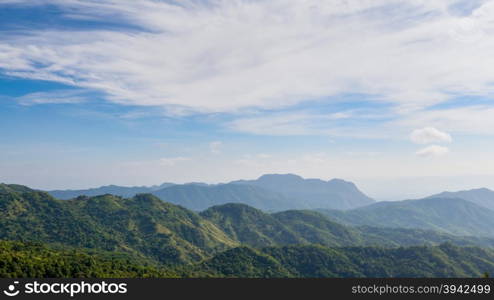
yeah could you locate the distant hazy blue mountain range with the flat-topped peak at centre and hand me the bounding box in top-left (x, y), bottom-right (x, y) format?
top-left (49, 174), bottom-right (374, 211)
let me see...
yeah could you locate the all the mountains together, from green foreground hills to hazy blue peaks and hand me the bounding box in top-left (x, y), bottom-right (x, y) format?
top-left (0, 175), bottom-right (494, 277)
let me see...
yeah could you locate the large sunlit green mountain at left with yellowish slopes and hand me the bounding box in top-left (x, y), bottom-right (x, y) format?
top-left (0, 184), bottom-right (237, 264)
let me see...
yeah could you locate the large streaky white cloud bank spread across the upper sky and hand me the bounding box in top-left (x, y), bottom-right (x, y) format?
top-left (0, 0), bottom-right (494, 117)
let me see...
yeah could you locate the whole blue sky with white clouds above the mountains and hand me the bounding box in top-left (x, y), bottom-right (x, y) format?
top-left (0, 0), bottom-right (494, 200)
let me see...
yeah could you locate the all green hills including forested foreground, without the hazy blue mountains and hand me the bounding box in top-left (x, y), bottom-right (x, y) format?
top-left (0, 184), bottom-right (494, 278)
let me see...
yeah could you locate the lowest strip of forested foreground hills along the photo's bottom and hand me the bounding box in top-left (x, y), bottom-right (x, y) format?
top-left (0, 241), bottom-right (494, 278)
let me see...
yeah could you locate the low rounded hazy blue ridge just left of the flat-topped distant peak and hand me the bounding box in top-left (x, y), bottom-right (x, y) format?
top-left (153, 184), bottom-right (296, 211)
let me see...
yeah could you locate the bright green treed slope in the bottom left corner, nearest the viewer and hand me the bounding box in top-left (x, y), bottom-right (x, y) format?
top-left (0, 241), bottom-right (179, 278)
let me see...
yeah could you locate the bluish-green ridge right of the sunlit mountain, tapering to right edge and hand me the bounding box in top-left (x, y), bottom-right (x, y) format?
top-left (200, 203), bottom-right (494, 248)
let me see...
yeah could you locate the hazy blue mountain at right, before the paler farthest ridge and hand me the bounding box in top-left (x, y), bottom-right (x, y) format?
top-left (320, 198), bottom-right (494, 237)
